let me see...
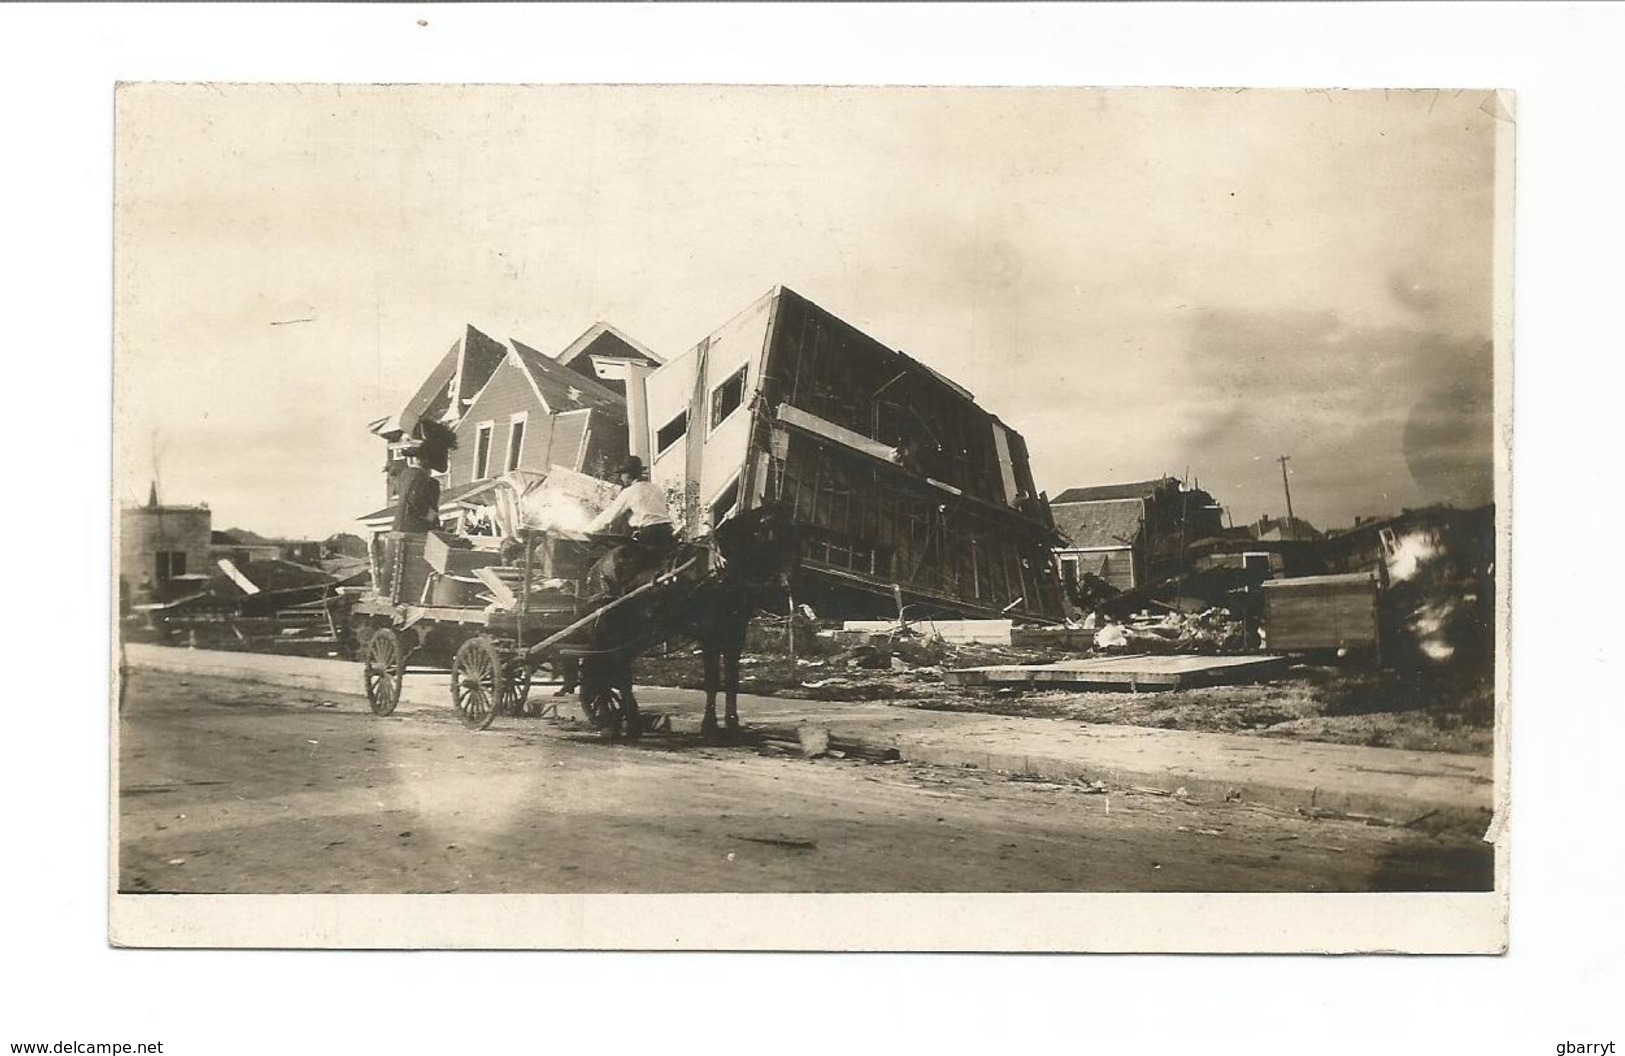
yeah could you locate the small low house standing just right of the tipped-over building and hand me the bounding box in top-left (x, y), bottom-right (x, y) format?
top-left (1050, 476), bottom-right (1224, 590)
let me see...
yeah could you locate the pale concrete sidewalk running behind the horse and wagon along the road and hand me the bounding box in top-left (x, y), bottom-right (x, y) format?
top-left (127, 645), bottom-right (1493, 830)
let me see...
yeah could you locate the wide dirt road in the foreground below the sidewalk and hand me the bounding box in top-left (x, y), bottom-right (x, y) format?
top-left (119, 671), bottom-right (1492, 894)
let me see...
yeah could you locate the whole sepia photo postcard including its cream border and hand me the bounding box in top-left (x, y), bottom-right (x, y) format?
top-left (109, 83), bottom-right (1515, 952)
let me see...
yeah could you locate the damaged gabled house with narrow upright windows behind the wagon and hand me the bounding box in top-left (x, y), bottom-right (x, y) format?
top-left (359, 323), bottom-right (660, 531)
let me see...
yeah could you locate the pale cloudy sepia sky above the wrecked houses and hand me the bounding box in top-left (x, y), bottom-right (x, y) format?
top-left (114, 84), bottom-right (1510, 536)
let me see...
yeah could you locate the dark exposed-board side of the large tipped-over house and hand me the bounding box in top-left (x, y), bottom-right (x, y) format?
top-left (752, 291), bottom-right (1060, 616)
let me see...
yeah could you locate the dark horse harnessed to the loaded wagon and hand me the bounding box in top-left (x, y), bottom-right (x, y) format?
top-left (580, 504), bottom-right (800, 741)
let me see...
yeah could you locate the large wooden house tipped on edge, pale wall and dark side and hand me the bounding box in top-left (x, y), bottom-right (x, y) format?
top-left (629, 286), bottom-right (1061, 621)
